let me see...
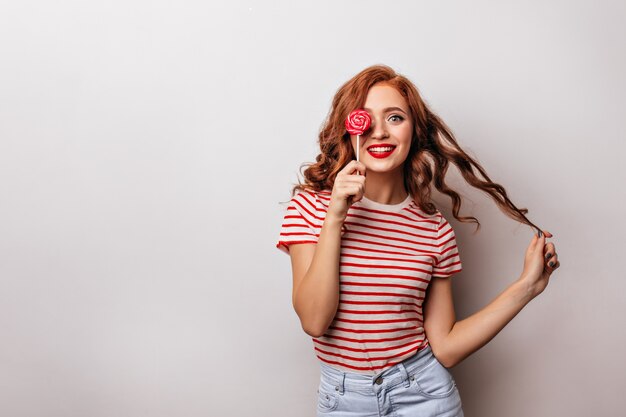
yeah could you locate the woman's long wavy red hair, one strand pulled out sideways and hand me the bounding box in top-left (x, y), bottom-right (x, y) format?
top-left (291, 65), bottom-right (541, 231)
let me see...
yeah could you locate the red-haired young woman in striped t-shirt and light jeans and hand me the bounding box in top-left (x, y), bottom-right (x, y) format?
top-left (276, 65), bottom-right (559, 417)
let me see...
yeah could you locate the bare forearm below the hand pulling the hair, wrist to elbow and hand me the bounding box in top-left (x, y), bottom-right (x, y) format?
top-left (442, 280), bottom-right (534, 368)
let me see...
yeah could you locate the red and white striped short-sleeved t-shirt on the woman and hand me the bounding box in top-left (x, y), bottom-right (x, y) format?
top-left (276, 191), bottom-right (462, 375)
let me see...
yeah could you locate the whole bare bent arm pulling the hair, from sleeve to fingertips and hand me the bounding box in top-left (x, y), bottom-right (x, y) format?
top-left (424, 232), bottom-right (560, 368)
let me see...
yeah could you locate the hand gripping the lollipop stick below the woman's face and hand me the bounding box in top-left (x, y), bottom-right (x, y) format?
top-left (327, 159), bottom-right (365, 221)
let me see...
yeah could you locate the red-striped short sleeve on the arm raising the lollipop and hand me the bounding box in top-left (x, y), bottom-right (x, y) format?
top-left (276, 191), bottom-right (323, 254)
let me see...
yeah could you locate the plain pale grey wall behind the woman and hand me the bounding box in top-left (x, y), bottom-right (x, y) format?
top-left (0, 0), bottom-right (626, 417)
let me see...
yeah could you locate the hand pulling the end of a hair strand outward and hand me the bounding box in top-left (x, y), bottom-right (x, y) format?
top-left (520, 230), bottom-right (561, 298)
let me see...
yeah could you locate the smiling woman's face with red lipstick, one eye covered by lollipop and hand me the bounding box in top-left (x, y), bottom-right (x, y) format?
top-left (350, 83), bottom-right (413, 172)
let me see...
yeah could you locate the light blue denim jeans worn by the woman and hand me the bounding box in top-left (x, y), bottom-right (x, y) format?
top-left (317, 346), bottom-right (463, 417)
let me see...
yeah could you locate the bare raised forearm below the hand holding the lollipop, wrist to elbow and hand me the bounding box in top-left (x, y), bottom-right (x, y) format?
top-left (294, 216), bottom-right (343, 337)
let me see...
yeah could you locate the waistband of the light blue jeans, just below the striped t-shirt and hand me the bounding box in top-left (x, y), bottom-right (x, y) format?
top-left (321, 345), bottom-right (434, 393)
